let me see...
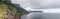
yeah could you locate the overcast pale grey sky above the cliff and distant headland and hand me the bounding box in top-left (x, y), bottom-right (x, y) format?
top-left (11, 0), bottom-right (60, 12)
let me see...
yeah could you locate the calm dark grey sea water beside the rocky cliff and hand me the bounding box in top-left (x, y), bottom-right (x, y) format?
top-left (22, 13), bottom-right (60, 19)
